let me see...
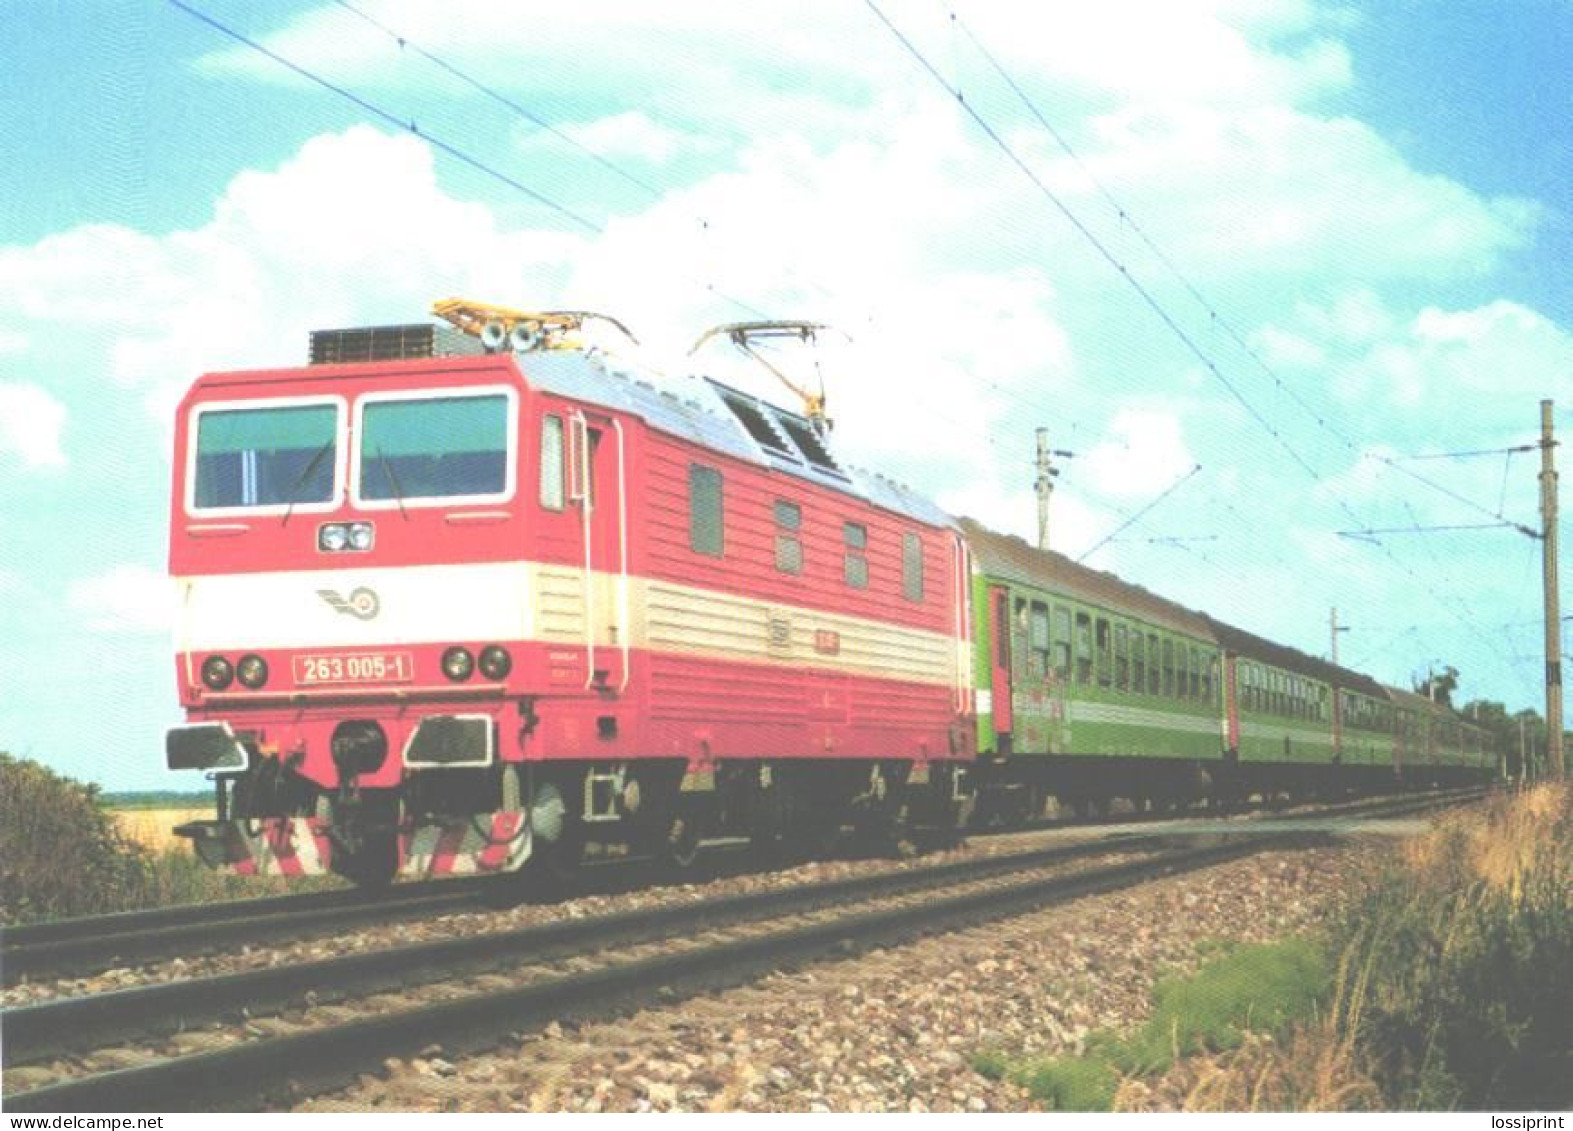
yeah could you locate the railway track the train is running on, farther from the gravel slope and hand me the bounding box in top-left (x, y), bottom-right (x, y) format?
top-left (0, 790), bottom-right (1480, 988)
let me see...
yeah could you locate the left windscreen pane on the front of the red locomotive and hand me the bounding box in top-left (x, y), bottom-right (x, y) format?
top-left (192, 404), bottom-right (338, 510)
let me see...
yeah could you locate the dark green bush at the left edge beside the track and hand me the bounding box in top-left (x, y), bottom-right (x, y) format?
top-left (0, 753), bottom-right (148, 923)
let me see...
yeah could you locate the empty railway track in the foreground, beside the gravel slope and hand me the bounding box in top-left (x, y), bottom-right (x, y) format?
top-left (0, 786), bottom-right (1478, 1112)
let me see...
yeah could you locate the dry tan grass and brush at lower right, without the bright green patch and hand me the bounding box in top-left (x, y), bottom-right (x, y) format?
top-left (1115, 783), bottom-right (1573, 1112)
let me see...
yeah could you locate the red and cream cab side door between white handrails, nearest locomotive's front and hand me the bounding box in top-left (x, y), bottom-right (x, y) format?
top-left (568, 412), bottom-right (632, 691)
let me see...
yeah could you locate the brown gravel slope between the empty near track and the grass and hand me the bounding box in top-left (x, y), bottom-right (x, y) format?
top-left (300, 840), bottom-right (1392, 1111)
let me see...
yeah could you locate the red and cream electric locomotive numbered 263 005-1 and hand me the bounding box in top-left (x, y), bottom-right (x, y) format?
top-left (167, 322), bottom-right (971, 882)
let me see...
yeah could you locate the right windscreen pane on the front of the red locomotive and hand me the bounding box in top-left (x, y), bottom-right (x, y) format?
top-left (359, 393), bottom-right (510, 502)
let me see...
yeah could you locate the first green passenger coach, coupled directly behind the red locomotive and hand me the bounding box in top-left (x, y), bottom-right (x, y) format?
top-left (960, 519), bottom-right (1224, 818)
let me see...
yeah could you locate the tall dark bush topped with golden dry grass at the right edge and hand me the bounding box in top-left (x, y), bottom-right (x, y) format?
top-left (1351, 787), bottom-right (1573, 1111)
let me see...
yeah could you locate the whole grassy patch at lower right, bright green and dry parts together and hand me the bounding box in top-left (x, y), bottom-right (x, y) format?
top-left (974, 785), bottom-right (1573, 1111)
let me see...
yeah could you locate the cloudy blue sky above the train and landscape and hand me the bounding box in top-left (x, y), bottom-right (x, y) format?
top-left (0, 0), bottom-right (1573, 788)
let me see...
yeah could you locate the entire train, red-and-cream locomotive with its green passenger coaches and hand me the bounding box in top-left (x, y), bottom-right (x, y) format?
top-left (165, 302), bottom-right (1491, 882)
